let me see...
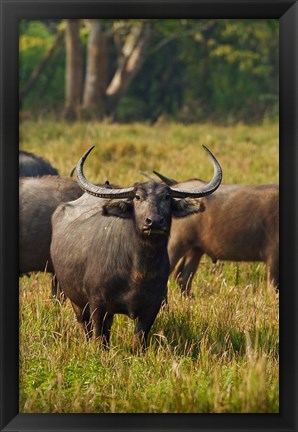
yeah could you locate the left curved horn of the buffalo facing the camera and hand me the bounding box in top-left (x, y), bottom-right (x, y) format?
top-left (76, 146), bottom-right (134, 199)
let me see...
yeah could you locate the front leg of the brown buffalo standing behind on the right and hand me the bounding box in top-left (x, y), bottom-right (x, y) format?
top-left (175, 248), bottom-right (203, 295)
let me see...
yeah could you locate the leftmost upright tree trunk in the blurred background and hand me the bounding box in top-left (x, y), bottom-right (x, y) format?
top-left (65, 19), bottom-right (83, 120)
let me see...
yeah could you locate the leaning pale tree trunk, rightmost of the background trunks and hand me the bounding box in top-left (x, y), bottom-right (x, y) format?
top-left (106, 23), bottom-right (151, 116)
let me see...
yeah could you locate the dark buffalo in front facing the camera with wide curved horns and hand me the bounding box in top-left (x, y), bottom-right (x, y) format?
top-left (51, 147), bottom-right (222, 351)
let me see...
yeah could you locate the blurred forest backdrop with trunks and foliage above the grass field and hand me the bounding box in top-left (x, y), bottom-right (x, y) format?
top-left (20, 19), bottom-right (278, 124)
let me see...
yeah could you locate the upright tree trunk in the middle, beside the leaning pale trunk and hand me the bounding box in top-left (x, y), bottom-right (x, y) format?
top-left (82, 20), bottom-right (108, 118)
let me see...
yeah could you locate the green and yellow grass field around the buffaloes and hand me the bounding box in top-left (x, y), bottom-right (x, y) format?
top-left (20, 120), bottom-right (279, 413)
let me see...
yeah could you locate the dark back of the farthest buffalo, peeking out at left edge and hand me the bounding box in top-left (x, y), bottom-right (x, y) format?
top-left (19, 150), bottom-right (58, 177)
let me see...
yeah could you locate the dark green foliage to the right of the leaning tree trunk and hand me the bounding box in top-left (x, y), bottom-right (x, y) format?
top-left (117, 20), bottom-right (278, 123)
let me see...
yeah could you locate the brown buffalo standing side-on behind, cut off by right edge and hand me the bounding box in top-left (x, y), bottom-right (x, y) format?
top-left (154, 171), bottom-right (279, 294)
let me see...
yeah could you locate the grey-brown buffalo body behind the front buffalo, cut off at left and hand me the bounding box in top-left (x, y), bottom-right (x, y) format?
top-left (19, 176), bottom-right (83, 295)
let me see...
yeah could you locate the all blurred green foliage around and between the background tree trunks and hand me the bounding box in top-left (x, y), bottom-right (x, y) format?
top-left (20, 19), bottom-right (279, 123)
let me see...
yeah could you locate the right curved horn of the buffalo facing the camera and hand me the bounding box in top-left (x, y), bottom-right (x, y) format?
top-left (170, 145), bottom-right (222, 198)
